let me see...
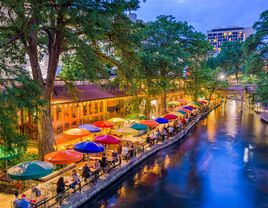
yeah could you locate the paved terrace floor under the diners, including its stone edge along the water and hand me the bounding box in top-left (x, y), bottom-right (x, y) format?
top-left (0, 103), bottom-right (217, 208)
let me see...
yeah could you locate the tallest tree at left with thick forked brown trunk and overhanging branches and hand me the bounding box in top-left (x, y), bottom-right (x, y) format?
top-left (0, 0), bottom-right (139, 158)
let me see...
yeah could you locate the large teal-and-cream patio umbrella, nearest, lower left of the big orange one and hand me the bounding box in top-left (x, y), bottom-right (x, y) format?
top-left (7, 160), bottom-right (53, 180)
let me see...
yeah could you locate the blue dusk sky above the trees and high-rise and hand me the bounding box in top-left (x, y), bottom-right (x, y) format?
top-left (135, 0), bottom-right (268, 33)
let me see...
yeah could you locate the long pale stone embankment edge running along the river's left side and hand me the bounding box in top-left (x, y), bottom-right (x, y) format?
top-left (61, 104), bottom-right (220, 208)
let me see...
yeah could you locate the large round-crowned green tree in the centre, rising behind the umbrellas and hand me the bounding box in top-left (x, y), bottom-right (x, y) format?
top-left (138, 16), bottom-right (208, 114)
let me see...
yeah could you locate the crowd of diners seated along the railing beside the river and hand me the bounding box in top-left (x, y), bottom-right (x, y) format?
top-left (13, 105), bottom-right (206, 208)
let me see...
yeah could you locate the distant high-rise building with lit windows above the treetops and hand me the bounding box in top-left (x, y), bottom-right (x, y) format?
top-left (207, 27), bottom-right (254, 53)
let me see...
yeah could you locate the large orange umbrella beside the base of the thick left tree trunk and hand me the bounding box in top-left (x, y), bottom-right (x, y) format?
top-left (45, 150), bottom-right (83, 165)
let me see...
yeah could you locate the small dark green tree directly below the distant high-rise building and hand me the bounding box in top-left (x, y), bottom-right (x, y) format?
top-left (217, 41), bottom-right (244, 84)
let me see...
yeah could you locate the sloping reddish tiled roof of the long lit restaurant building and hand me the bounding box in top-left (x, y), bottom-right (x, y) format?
top-left (52, 84), bottom-right (124, 103)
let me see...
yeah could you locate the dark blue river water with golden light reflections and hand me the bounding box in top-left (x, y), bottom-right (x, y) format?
top-left (83, 101), bottom-right (268, 208)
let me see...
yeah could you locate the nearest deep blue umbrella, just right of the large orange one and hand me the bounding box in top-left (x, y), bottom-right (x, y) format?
top-left (74, 142), bottom-right (104, 154)
